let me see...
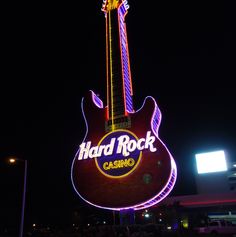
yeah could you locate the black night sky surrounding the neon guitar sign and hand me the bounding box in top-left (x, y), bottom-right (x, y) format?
top-left (0, 0), bottom-right (236, 228)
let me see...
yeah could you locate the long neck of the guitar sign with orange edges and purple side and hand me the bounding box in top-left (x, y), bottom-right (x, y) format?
top-left (106, 4), bottom-right (133, 120)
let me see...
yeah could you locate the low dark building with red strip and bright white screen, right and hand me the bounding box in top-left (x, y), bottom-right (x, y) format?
top-left (152, 151), bottom-right (236, 228)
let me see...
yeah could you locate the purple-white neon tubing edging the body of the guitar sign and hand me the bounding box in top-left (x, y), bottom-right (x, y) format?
top-left (71, 90), bottom-right (177, 211)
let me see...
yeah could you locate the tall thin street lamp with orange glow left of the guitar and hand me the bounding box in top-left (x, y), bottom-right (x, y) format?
top-left (9, 158), bottom-right (27, 237)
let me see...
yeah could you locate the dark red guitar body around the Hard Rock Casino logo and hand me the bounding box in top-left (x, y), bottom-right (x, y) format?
top-left (71, 92), bottom-right (176, 210)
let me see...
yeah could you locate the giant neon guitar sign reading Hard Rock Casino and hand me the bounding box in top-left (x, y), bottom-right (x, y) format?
top-left (71, 0), bottom-right (177, 210)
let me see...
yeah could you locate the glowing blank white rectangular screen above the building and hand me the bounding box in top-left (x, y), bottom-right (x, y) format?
top-left (195, 151), bottom-right (227, 174)
